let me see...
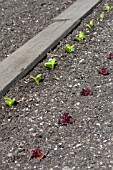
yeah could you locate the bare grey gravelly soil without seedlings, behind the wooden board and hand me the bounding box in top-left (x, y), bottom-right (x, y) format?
top-left (0, 0), bottom-right (76, 61)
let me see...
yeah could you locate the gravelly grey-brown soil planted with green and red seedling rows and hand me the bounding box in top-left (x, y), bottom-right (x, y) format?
top-left (0, 0), bottom-right (113, 170)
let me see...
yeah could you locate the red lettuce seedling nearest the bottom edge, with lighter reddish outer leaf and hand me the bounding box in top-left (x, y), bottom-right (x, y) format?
top-left (30, 147), bottom-right (45, 161)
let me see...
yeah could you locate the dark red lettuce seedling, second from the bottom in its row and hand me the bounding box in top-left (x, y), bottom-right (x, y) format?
top-left (58, 113), bottom-right (76, 126)
